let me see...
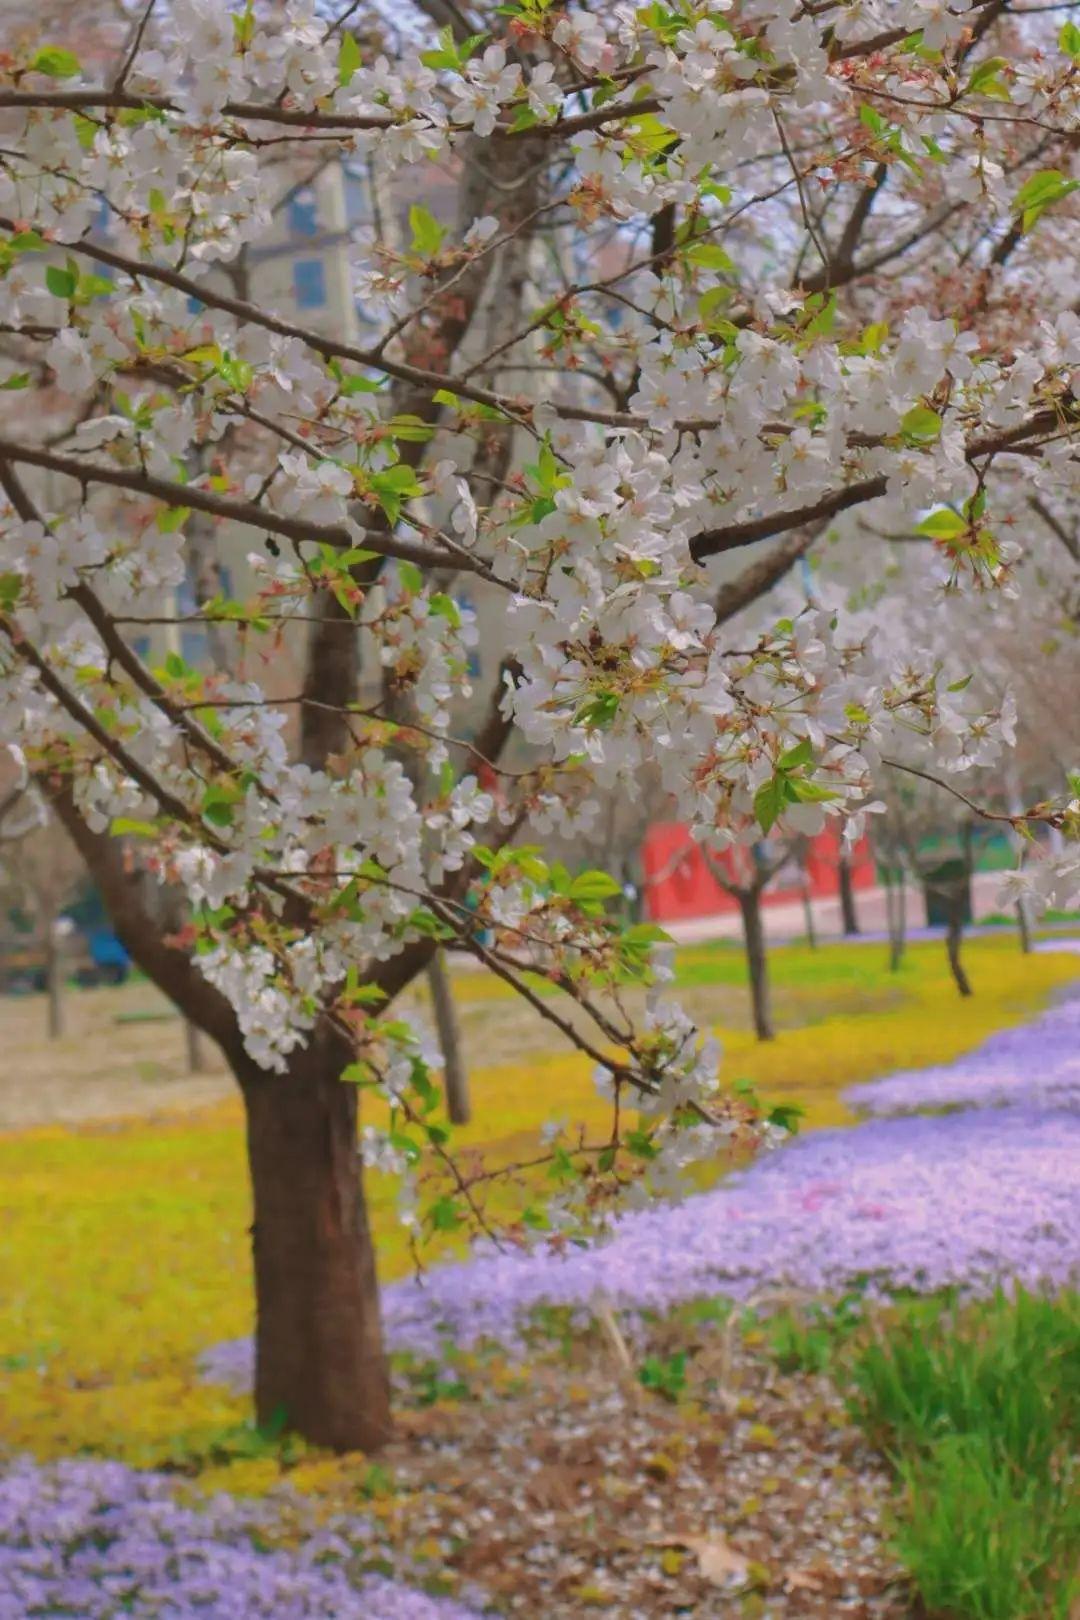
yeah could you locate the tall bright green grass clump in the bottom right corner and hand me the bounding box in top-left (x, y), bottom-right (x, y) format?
top-left (847, 1291), bottom-right (1080, 1620)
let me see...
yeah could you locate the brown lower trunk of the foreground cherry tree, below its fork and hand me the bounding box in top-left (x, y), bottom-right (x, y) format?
top-left (238, 1040), bottom-right (390, 1452)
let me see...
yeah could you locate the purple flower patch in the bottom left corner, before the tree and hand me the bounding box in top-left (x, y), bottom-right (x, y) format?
top-left (0, 1460), bottom-right (479, 1620)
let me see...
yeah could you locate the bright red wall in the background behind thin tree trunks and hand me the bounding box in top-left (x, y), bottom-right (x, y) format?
top-left (641, 821), bottom-right (876, 922)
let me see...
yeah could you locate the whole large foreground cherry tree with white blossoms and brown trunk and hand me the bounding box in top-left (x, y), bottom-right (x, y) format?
top-left (0, 0), bottom-right (1080, 1447)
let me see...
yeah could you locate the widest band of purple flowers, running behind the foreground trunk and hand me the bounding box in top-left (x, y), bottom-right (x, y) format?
top-left (204, 1106), bottom-right (1080, 1385)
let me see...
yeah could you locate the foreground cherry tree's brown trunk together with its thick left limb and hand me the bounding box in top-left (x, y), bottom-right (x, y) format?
top-left (52, 791), bottom-right (396, 1450)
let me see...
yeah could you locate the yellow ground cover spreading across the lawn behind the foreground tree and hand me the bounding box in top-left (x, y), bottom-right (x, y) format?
top-left (0, 938), bottom-right (1078, 1482)
